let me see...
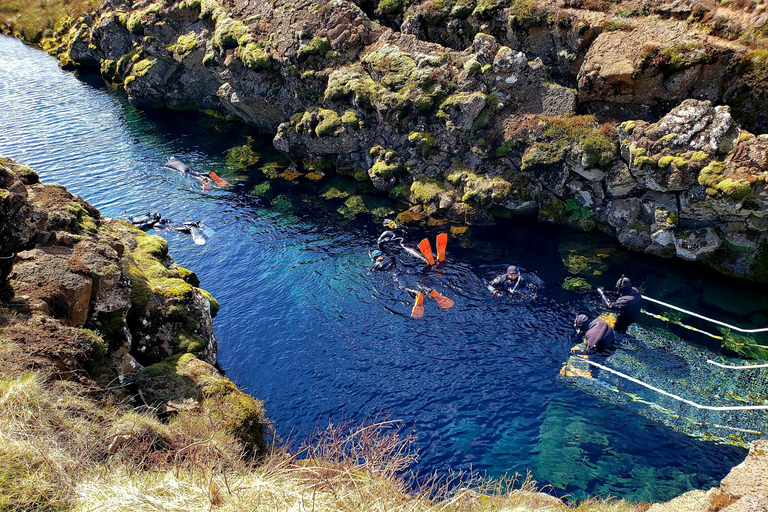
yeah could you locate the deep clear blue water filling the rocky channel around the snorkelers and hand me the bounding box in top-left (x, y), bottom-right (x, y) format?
top-left (0, 37), bottom-right (766, 501)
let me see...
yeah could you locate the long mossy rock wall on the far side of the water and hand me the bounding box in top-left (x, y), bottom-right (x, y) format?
top-left (19, 0), bottom-right (768, 281)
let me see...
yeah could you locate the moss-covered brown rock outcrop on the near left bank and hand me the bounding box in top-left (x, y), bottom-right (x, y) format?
top-left (0, 159), bottom-right (269, 453)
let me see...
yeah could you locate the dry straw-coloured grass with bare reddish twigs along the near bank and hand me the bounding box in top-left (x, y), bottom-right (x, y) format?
top-left (0, 373), bottom-right (646, 512)
